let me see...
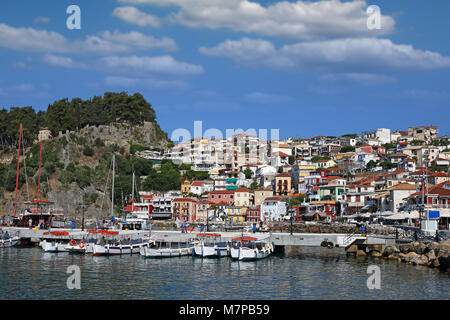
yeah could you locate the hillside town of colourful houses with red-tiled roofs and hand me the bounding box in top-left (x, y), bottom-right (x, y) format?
top-left (125, 126), bottom-right (450, 230)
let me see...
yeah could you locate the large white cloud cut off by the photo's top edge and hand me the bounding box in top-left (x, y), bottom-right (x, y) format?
top-left (119, 0), bottom-right (395, 41)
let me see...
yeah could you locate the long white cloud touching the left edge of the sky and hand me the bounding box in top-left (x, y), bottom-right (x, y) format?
top-left (0, 24), bottom-right (177, 55)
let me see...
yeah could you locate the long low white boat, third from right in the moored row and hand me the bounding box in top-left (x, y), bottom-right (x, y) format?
top-left (140, 241), bottom-right (194, 258)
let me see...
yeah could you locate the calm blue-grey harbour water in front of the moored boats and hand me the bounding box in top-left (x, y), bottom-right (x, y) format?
top-left (0, 248), bottom-right (450, 300)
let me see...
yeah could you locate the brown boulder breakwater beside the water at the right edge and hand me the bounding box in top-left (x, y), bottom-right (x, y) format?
top-left (347, 240), bottom-right (450, 270)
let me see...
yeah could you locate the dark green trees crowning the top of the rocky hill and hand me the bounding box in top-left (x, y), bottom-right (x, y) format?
top-left (0, 92), bottom-right (158, 149)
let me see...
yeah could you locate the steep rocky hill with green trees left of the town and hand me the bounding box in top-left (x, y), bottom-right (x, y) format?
top-left (0, 93), bottom-right (171, 220)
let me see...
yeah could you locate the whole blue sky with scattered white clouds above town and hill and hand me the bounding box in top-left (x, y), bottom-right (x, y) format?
top-left (0, 0), bottom-right (450, 138)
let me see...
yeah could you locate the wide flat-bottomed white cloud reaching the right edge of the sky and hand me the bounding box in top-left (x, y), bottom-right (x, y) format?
top-left (199, 38), bottom-right (450, 74)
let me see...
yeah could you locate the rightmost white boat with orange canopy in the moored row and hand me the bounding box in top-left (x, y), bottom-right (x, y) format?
top-left (230, 237), bottom-right (274, 261)
